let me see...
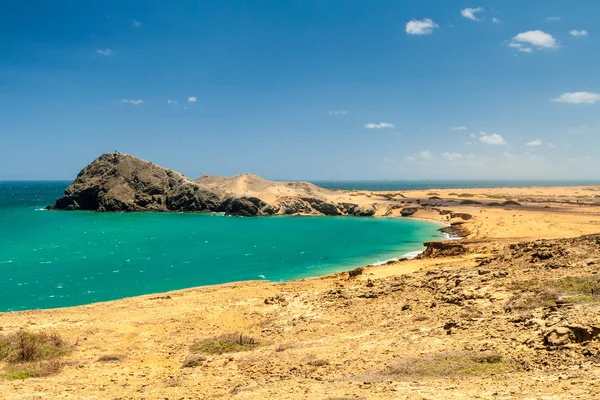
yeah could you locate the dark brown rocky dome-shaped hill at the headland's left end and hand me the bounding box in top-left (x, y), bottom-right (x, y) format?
top-left (52, 153), bottom-right (221, 211)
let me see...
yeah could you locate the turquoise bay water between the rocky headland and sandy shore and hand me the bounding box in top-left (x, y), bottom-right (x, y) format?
top-left (0, 182), bottom-right (441, 311)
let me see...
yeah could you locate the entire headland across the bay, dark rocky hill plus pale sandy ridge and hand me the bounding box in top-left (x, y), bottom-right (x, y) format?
top-left (48, 152), bottom-right (375, 216)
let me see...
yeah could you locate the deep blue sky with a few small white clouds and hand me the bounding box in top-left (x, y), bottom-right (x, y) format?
top-left (0, 0), bottom-right (600, 180)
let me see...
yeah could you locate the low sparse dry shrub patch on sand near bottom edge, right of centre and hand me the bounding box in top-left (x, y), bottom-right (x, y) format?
top-left (388, 352), bottom-right (511, 378)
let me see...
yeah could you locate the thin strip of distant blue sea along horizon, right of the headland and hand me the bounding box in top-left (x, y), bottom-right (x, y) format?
top-left (311, 180), bottom-right (600, 191)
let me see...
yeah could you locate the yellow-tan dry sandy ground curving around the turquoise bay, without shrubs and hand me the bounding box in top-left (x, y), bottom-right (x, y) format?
top-left (0, 187), bottom-right (600, 400)
